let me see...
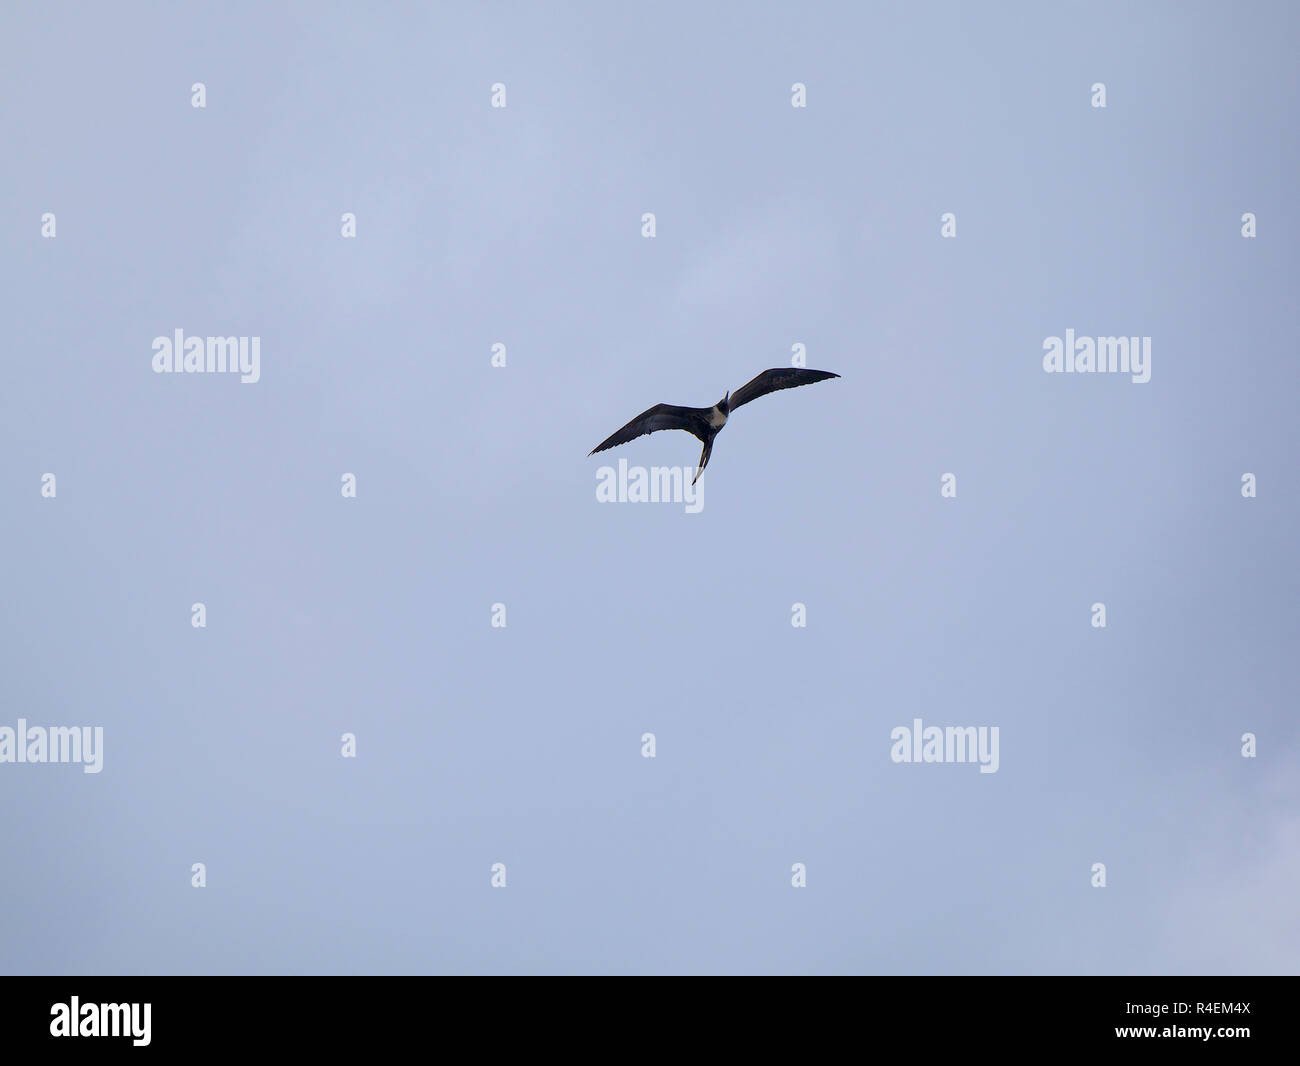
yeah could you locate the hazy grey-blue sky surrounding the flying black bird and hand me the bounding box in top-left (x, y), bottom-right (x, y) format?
top-left (0, 4), bottom-right (1300, 972)
